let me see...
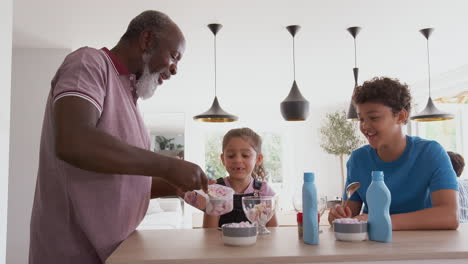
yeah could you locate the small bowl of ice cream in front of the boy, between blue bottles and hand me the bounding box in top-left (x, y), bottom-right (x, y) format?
top-left (333, 218), bottom-right (367, 241)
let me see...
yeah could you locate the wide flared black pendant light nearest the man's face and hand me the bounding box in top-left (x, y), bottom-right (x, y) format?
top-left (193, 24), bottom-right (238, 123)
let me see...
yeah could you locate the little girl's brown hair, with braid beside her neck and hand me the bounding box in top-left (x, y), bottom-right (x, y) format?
top-left (223, 127), bottom-right (266, 181)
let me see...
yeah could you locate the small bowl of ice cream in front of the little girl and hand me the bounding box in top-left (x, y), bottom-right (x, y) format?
top-left (221, 222), bottom-right (257, 246)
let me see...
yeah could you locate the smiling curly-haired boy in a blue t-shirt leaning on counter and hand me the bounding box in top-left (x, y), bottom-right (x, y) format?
top-left (328, 77), bottom-right (458, 230)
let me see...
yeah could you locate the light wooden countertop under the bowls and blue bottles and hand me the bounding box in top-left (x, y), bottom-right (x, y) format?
top-left (106, 224), bottom-right (468, 264)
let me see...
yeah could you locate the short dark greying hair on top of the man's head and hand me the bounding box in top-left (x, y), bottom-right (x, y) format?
top-left (122, 10), bottom-right (174, 40)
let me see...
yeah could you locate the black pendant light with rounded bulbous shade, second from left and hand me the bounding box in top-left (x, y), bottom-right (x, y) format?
top-left (281, 25), bottom-right (309, 121)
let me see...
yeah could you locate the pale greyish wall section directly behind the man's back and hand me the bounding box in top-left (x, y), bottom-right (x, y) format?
top-left (6, 48), bottom-right (69, 264)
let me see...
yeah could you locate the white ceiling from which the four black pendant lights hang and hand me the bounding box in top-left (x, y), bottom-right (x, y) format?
top-left (13, 0), bottom-right (468, 118)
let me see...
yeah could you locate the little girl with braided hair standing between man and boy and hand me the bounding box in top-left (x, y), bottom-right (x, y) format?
top-left (203, 128), bottom-right (278, 228)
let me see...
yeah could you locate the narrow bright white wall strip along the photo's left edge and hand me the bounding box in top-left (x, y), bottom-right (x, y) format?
top-left (0, 0), bottom-right (13, 263)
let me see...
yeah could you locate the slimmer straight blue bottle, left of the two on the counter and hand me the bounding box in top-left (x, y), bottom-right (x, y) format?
top-left (302, 172), bottom-right (319, 245)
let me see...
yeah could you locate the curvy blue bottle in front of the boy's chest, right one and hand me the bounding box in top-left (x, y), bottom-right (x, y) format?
top-left (366, 171), bottom-right (392, 243)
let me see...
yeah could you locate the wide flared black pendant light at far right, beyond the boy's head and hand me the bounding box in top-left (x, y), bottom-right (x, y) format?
top-left (410, 28), bottom-right (454, 122)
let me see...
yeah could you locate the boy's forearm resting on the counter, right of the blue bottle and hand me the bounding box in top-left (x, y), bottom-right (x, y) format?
top-left (391, 206), bottom-right (458, 230)
